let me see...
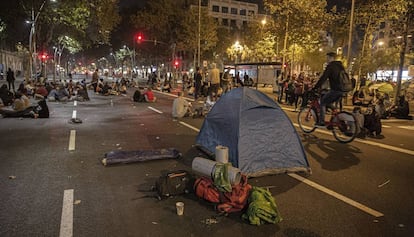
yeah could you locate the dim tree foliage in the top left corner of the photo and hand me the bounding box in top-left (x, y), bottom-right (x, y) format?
top-left (0, 0), bottom-right (120, 49)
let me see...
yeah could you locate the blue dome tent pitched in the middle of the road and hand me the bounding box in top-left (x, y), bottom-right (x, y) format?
top-left (196, 87), bottom-right (310, 177)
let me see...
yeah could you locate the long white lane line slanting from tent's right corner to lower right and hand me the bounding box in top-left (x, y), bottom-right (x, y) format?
top-left (288, 173), bottom-right (384, 217)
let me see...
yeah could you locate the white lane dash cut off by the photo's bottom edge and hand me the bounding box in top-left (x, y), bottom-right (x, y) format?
top-left (59, 189), bottom-right (74, 237)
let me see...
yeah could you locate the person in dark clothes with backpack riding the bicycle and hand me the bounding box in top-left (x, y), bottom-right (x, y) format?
top-left (314, 52), bottom-right (344, 126)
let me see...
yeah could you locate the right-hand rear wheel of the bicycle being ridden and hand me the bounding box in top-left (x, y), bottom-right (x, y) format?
top-left (332, 111), bottom-right (357, 143)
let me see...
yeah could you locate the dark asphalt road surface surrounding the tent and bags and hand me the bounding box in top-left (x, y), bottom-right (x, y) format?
top-left (0, 82), bottom-right (414, 237)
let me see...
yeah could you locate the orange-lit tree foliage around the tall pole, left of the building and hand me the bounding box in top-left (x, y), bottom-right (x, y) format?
top-left (132, 0), bottom-right (218, 64)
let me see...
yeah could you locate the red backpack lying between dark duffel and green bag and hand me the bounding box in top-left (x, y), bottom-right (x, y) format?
top-left (194, 175), bottom-right (252, 213)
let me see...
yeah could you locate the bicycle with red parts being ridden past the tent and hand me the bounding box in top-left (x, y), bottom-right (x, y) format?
top-left (298, 91), bottom-right (357, 143)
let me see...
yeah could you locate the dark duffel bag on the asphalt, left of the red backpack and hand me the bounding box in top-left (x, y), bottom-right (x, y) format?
top-left (155, 170), bottom-right (194, 199)
